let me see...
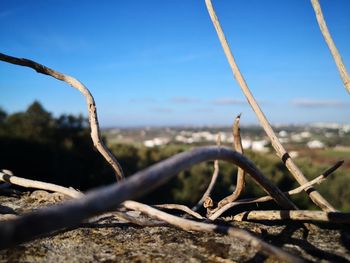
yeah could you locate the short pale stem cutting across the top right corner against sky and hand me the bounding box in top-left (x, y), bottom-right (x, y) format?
top-left (311, 0), bottom-right (350, 93)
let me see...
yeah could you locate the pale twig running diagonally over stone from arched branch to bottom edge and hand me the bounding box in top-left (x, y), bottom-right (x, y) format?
top-left (122, 201), bottom-right (302, 262)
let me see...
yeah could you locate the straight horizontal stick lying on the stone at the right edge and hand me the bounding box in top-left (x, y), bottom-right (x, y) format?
top-left (230, 210), bottom-right (350, 224)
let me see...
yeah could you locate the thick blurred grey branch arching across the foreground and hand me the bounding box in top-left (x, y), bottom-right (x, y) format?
top-left (0, 146), bottom-right (295, 249)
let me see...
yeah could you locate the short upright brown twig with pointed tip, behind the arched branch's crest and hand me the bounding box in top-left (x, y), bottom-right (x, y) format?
top-left (218, 114), bottom-right (245, 208)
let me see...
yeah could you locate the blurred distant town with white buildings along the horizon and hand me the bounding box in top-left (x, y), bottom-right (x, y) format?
top-left (103, 123), bottom-right (350, 157)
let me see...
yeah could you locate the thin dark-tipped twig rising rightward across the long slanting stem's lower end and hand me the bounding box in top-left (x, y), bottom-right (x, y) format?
top-left (208, 161), bottom-right (344, 220)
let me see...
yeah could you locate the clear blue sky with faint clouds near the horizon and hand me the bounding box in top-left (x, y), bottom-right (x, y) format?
top-left (0, 0), bottom-right (350, 127)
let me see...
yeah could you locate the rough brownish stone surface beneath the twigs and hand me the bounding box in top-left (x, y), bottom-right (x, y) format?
top-left (0, 191), bottom-right (350, 262)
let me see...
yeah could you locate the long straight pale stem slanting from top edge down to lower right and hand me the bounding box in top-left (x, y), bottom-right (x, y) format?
top-left (205, 0), bottom-right (335, 211)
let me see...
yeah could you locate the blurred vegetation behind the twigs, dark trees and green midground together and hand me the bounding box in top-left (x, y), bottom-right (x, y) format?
top-left (0, 102), bottom-right (350, 211)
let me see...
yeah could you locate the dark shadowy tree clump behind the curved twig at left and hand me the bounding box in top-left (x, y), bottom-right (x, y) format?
top-left (0, 102), bottom-right (113, 190)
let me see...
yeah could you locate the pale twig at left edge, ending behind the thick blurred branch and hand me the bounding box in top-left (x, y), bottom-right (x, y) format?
top-left (0, 172), bottom-right (83, 198)
